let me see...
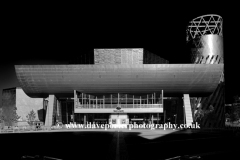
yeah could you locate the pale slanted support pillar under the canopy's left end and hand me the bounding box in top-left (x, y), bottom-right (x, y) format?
top-left (45, 95), bottom-right (55, 126)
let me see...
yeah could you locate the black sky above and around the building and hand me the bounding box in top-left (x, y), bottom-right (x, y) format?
top-left (0, 6), bottom-right (240, 105)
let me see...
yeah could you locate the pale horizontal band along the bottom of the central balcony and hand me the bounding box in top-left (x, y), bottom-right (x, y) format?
top-left (76, 104), bottom-right (162, 109)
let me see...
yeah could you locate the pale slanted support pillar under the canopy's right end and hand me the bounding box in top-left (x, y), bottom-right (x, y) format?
top-left (183, 94), bottom-right (193, 126)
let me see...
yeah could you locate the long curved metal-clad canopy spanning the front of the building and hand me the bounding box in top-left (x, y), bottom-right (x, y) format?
top-left (15, 64), bottom-right (223, 97)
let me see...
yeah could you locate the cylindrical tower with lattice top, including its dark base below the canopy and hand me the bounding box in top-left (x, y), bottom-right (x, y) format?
top-left (187, 14), bottom-right (225, 127)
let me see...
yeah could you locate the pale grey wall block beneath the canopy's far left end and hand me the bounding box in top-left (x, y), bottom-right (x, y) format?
top-left (16, 88), bottom-right (44, 122)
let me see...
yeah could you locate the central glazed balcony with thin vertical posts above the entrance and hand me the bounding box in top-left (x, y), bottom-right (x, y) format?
top-left (74, 92), bottom-right (163, 109)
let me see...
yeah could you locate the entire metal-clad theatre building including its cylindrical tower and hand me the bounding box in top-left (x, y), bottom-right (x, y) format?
top-left (0, 15), bottom-right (224, 126)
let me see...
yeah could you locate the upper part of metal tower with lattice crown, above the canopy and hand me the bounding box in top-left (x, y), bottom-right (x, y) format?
top-left (186, 14), bottom-right (224, 64)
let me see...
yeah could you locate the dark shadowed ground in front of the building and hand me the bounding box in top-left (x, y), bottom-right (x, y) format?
top-left (0, 129), bottom-right (240, 160)
